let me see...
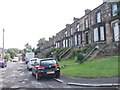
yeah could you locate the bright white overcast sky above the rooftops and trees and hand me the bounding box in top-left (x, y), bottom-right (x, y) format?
top-left (0, 0), bottom-right (103, 49)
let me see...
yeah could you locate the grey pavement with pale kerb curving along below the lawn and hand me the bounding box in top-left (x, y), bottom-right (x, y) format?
top-left (55, 76), bottom-right (120, 87)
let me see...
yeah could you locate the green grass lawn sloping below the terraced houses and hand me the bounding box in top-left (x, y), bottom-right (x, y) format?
top-left (59, 56), bottom-right (120, 78)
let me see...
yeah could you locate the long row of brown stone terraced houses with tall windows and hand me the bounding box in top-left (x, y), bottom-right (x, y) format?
top-left (40, 2), bottom-right (120, 51)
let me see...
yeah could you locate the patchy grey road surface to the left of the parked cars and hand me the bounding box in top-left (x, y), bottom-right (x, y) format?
top-left (0, 62), bottom-right (79, 89)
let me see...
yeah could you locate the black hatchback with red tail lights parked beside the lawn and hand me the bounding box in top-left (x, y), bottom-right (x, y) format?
top-left (32, 58), bottom-right (60, 80)
